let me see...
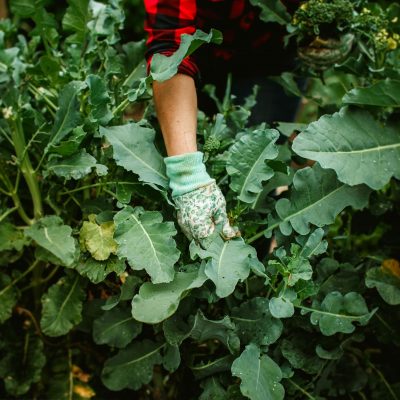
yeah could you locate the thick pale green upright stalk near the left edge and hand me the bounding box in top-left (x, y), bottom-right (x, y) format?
top-left (12, 115), bottom-right (43, 220)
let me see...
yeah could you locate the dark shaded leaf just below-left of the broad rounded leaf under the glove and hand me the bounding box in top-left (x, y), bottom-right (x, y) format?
top-left (93, 307), bottom-right (142, 348)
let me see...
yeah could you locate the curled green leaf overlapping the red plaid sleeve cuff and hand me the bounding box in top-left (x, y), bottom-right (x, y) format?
top-left (150, 29), bottom-right (222, 82)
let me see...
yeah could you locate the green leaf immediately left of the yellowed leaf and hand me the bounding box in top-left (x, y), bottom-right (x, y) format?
top-left (25, 215), bottom-right (75, 266)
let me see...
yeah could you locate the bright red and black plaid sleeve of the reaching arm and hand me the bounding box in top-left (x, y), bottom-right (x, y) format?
top-left (144, 0), bottom-right (199, 80)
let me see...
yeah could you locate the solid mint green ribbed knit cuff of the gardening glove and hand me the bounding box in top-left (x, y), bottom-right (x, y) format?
top-left (164, 151), bottom-right (215, 197)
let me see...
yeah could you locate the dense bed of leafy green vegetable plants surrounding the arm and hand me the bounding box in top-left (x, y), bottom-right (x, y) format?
top-left (0, 0), bottom-right (400, 400)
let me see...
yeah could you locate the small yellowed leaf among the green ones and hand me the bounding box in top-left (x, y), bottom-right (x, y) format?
top-left (79, 214), bottom-right (118, 261)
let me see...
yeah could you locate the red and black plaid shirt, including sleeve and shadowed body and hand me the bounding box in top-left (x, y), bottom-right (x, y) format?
top-left (144, 0), bottom-right (299, 77)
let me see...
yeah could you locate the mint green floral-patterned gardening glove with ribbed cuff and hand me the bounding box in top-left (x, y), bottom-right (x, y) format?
top-left (164, 151), bottom-right (240, 244)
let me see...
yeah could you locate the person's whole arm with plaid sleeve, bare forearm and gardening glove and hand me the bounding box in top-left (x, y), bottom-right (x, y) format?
top-left (145, 0), bottom-right (240, 245)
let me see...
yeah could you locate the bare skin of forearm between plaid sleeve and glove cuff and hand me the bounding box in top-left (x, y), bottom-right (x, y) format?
top-left (153, 74), bottom-right (197, 156)
